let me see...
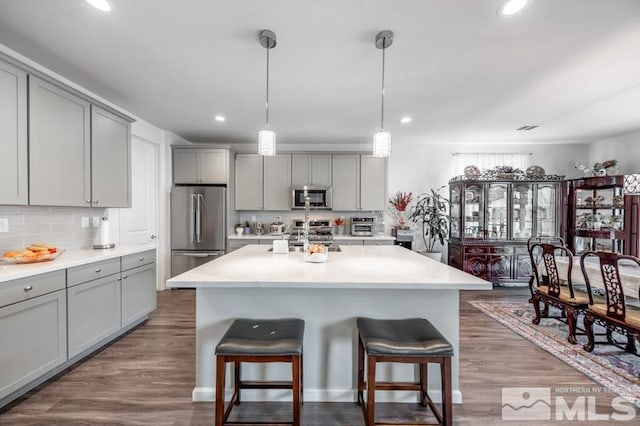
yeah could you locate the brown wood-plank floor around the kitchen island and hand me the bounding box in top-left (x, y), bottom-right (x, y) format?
top-left (0, 288), bottom-right (628, 426)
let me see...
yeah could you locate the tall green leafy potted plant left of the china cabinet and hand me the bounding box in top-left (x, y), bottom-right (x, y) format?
top-left (409, 186), bottom-right (449, 260)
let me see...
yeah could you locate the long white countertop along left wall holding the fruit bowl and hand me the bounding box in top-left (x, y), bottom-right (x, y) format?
top-left (0, 244), bottom-right (156, 282)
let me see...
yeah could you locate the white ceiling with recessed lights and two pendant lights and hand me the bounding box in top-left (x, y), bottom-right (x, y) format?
top-left (0, 0), bottom-right (640, 145)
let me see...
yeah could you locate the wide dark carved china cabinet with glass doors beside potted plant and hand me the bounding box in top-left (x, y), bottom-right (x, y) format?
top-left (448, 175), bottom-right (562, 284)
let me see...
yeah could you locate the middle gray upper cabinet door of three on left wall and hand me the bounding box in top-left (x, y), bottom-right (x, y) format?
top-left (29, 76), bottom-right (91, 206)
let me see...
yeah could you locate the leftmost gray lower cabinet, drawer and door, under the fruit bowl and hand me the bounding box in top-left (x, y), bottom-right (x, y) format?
top-left (0, 271), bottom-right (67, 401)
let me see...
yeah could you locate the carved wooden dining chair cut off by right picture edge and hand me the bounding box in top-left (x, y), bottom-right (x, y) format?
top-left (580, 251), bottom-right (640, 355)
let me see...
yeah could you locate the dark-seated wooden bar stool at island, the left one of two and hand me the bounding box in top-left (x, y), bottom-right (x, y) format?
top-left (215, 318), bottom-right (304, 426)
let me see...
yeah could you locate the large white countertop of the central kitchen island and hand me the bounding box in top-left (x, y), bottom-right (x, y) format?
top-left (167, 244), bottom-right (492, 290)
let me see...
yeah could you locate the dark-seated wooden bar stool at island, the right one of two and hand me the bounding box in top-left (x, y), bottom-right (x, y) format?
top-left (357, 317), bottom-right (453, 426)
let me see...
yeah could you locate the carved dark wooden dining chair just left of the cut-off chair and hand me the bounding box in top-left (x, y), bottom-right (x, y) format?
top-left (531, 243), bottom-right (589, 344)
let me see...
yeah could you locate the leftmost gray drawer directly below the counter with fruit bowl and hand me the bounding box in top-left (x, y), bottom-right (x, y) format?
top-left (0, 269), bottom-right (65, 307)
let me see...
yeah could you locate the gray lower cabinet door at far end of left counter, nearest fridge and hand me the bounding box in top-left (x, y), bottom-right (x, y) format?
top-left (121, 263), bottom-right (156, 327)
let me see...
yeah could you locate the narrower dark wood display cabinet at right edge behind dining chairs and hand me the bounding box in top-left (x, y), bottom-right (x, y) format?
top-left (562, 175), bottom-right (638, 256)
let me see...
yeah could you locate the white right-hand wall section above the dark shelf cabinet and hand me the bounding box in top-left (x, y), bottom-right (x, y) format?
top-left (585, 130), bottom-right (640, 174)
